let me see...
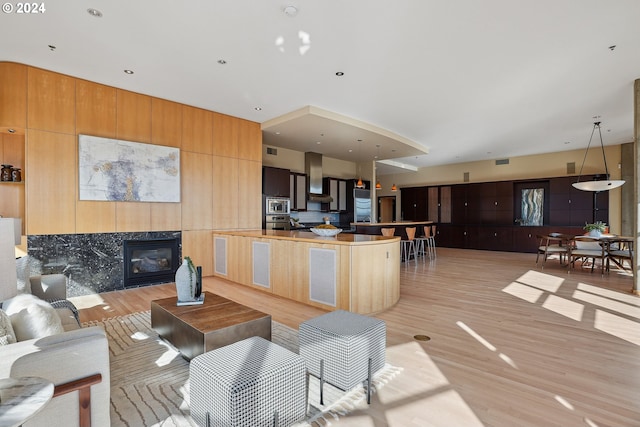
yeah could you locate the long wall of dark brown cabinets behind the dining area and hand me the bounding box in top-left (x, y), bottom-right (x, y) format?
top-left (412, 176), bottom-right (609, 253)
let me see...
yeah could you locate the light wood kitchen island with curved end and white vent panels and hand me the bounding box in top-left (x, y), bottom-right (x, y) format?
top-left (213, 230), bottom-right (400, 314)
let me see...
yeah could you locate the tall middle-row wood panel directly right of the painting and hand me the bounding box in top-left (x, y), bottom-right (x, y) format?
top-left (180, 151), bottom-right (213, 230)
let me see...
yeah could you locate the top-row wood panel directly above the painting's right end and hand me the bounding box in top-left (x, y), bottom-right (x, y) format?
top-left (151, 98), bottom-right (182, 148)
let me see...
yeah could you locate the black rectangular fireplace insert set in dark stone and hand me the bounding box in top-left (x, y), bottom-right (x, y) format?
top-left (122, 239), bottom-right (180, 288)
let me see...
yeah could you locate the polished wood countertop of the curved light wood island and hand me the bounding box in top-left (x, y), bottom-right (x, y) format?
top-left (214, 230), bottom-right (400, 245)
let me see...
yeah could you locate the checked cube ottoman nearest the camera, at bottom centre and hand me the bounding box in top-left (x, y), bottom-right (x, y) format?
top-left (189, 337), bottom-right (307, 427)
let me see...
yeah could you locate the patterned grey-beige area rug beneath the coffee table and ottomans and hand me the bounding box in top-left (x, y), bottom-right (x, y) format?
top-left (84, 311), bottom-right (402, 427)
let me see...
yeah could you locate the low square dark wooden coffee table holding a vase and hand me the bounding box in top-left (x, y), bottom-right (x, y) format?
top-left (151, 292), bottom-right (271, 360)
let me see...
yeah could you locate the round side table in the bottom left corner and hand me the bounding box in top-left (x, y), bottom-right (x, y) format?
top-left (0, 377), bottom-right (53, 427)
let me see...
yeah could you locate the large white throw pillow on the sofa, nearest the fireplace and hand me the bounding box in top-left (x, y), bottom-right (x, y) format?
top-left (4, 294), bottom-right (64, 341)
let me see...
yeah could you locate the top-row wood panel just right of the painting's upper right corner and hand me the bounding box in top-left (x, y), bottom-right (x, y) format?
top-left (182, 105), bottom-right (214, 154)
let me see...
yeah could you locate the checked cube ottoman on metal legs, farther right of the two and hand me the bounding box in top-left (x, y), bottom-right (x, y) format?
top-left (299, 310), bottom-right (387, 404)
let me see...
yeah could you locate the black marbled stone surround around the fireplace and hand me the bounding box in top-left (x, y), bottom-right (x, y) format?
top-left (27, 231), bottom-right (182, 297)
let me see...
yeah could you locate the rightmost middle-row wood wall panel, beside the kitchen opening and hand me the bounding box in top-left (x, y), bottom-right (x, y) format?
top-left (238, 160), bottom-right (262, 228)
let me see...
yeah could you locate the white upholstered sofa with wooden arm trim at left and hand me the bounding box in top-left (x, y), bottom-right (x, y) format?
top-left (0, 275), bottom-right (111, 427)
